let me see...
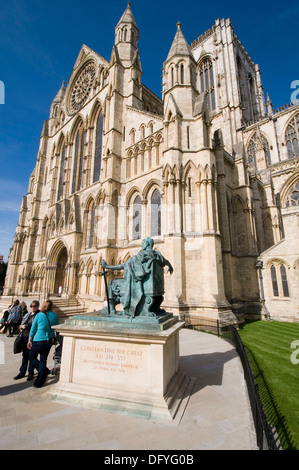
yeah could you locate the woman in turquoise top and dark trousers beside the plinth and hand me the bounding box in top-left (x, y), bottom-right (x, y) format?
top-left (27, 300), bottom-right (59, 388)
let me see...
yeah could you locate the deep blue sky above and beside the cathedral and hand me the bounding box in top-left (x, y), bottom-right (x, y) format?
top-left (0, 0), bottom-right (299, 260)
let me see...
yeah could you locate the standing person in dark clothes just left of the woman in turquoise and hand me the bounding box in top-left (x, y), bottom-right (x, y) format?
top-left (14, 300), bottom-right (39, 381)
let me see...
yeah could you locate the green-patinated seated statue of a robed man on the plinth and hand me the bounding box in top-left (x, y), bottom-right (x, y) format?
top-left (101, 238), bottom-right (173, 317)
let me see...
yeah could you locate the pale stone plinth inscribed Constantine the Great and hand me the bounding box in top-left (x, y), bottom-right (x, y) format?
top-left (51, 316), bottom-right (193, 420)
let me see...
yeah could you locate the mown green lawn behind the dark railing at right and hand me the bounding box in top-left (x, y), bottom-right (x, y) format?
top-left (239, 321), bottom-right (299, 450)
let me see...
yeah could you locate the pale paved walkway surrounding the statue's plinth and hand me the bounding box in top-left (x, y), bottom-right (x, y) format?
top-left (0, 329), bottom-right (256, 454)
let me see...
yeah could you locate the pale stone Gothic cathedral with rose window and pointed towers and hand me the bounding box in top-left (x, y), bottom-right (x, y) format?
top-left (4, 3), bottom-right (299, 324)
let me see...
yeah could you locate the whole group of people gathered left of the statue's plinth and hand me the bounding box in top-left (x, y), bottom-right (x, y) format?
top-left (1, 300), bottom-right (59, 388)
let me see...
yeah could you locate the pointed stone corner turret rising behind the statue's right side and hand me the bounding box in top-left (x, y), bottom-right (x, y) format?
top-left (163, 23), bottom-right (234, 319)
